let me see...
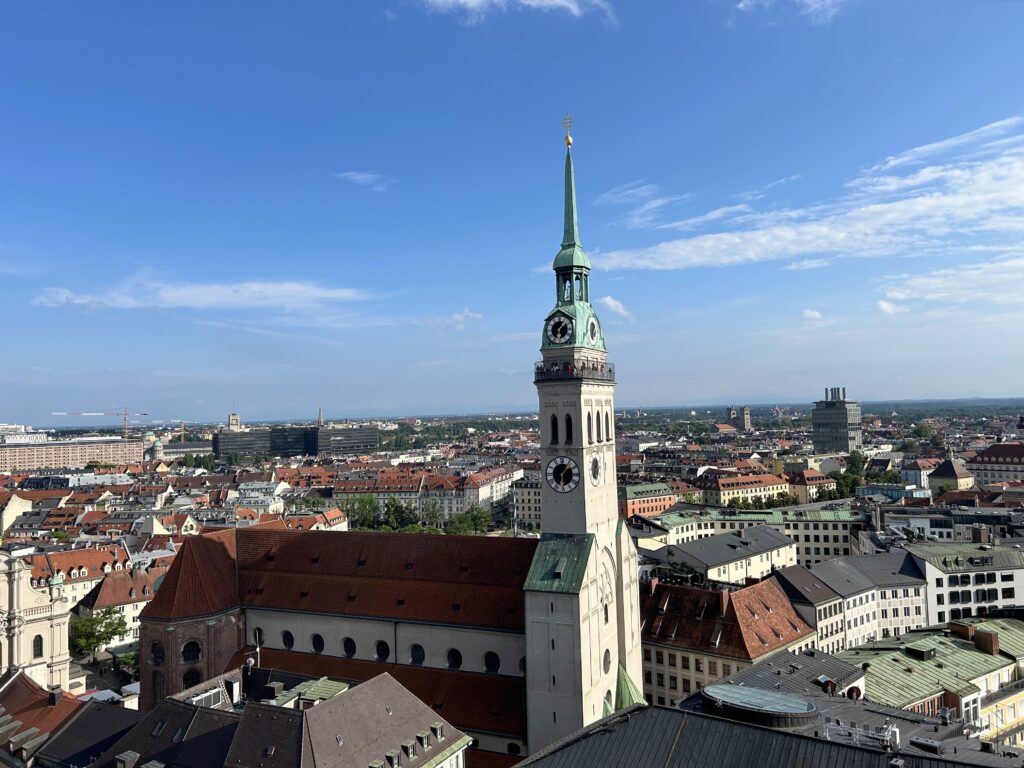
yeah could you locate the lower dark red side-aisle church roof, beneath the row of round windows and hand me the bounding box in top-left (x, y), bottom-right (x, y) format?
top-left (224, 651), bottom-right (526, 738)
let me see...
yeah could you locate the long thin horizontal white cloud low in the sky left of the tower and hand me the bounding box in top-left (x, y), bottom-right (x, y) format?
top-left (32, 280), bottom-right (368, 311)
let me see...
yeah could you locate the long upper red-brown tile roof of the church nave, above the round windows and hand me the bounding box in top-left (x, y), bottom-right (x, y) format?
top-left (237, 528), bottom-right (537, 632)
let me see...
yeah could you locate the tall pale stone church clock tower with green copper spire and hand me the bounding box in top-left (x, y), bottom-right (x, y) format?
top-left (524, 119), bottom-right (643, 753)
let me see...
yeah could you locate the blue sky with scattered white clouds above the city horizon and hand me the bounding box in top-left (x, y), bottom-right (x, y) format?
top-left (0, 0), bottom-right (1024, 423)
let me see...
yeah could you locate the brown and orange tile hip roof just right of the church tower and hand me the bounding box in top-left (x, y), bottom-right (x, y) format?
top-left (640, 581), bottom-right (814, 662)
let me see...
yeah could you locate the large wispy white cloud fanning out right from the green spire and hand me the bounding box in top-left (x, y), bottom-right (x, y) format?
top-left (595, 119), bottom-right (1024, 269)
